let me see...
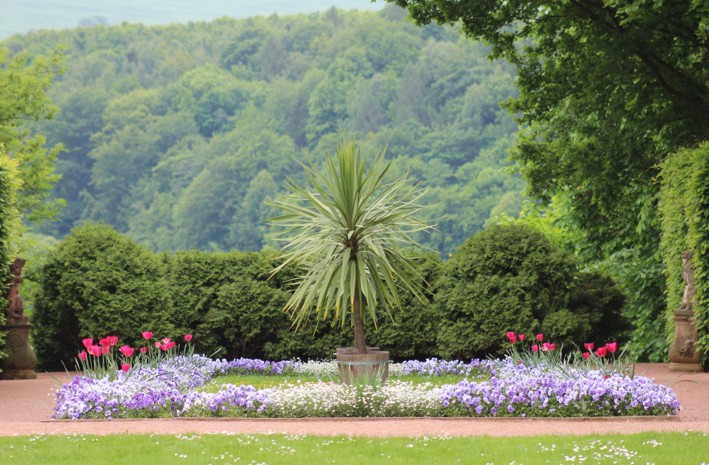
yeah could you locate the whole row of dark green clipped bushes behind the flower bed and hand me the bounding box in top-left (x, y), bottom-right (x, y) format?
top-left (33, 225), bottom-right (622, 369)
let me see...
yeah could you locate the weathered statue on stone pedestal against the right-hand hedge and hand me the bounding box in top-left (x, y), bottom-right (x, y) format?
top-left (669, 252), bottom-right (703, 372)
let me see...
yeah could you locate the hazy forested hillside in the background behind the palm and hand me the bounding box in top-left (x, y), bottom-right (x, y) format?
top-left (0, 7), bottom-right (523, 256)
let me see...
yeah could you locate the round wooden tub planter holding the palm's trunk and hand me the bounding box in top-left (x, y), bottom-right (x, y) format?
top-left (335, 347), bottom-right (389, 385)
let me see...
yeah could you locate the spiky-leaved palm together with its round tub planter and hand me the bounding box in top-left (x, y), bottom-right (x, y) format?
top-left (271, 141), bottom-right (429, 384)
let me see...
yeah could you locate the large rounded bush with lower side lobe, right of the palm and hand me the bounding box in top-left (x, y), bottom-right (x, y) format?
top-left (436, 224), bottom-right (624, 359)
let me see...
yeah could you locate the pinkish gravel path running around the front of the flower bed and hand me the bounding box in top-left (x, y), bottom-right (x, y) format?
top-left (0, 363), bottom-right (709, 437)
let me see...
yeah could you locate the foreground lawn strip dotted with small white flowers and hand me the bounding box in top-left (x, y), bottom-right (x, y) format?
top-left (0, 433), bottom-right (709, 465)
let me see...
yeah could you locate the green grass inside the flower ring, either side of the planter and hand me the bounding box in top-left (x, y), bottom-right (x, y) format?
top-left (201, 374), bottom-right (476, 392)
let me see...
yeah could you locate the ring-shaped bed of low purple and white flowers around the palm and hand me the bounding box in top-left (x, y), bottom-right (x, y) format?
top-left (54, 355), bottom-right (680, 419)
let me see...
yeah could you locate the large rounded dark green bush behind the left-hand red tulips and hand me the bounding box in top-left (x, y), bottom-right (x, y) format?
top-left (32, 225), bottom-right (173, 369)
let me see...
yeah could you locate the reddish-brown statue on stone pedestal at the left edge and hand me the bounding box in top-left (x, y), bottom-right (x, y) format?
top-left (0, 258), bottom-right (37, 379)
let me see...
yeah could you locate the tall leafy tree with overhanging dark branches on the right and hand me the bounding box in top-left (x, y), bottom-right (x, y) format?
top-left (388, 0), bottom-right (709, 361)
